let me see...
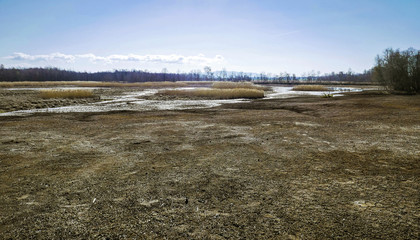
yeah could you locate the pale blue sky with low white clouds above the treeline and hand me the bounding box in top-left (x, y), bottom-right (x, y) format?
top-left (0, 0), bottom-right (420, 75)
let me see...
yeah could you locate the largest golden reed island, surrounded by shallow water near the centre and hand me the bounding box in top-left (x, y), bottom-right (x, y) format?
top-left (159, 88), bottom-right (264, 99)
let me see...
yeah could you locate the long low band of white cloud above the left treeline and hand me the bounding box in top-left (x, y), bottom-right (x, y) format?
top-left (6, 53), bottom-right (225, 65)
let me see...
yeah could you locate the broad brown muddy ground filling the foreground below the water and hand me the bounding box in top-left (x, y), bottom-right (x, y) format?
top-left (0, 89), bottom-right (420, 239)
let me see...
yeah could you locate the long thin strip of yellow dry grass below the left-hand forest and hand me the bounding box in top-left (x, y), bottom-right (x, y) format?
top-left (0, 81), bottom-right (188, 88)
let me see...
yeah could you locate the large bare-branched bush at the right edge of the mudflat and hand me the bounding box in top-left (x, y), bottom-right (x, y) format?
top-left (373, 48), bottom-right (420, 94)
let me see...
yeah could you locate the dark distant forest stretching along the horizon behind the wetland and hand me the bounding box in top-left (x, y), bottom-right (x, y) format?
top-left (0, 65), bottom-right (372, 84)
